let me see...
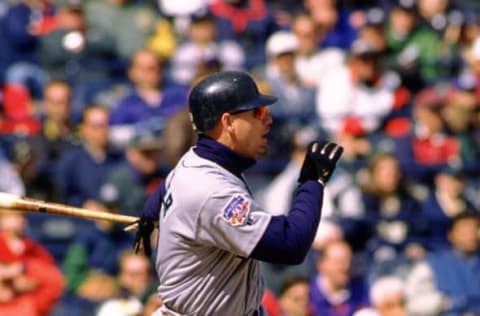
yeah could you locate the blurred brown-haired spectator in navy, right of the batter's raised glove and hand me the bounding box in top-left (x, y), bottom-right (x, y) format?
top-left (359, 153), bottom-right (427, 278)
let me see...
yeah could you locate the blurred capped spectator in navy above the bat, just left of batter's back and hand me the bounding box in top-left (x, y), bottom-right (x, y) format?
top-left (100, 127), bottom-right (167, 216)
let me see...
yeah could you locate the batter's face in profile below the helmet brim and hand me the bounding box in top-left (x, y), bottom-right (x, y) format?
top-left (231, 106), bottom-right (273, 158)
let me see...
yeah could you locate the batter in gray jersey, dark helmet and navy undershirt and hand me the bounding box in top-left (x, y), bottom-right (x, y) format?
top-left (135, 71), bottom-right (343, 316)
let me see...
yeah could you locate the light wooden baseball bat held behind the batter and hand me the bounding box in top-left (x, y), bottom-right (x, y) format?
top-left (0, 192), bottom-right (138, 224)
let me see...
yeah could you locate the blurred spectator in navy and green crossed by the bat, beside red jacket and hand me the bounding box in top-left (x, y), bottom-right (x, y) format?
top-left (62, 200), bottom-right (133, 315)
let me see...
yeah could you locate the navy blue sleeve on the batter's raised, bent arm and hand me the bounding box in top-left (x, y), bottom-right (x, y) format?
top-left (251, 181), bottom-right (323, 264)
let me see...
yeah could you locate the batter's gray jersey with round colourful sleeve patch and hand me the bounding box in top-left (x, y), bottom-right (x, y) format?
top-left (156, 149), bottom-right (271, 315)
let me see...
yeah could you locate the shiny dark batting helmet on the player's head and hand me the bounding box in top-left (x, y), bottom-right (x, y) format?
top-left (188, 71), bottom-right (277, 133)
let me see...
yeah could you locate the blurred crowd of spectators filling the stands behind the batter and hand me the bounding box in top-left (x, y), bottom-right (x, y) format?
top-left (0, 0), bottom-right (480, 316)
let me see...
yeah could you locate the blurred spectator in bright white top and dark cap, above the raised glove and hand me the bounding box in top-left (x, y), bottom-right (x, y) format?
top-left (316, 39), bottom-right (398, 135)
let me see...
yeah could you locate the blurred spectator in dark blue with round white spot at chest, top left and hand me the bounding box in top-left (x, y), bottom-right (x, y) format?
top-left (39, 4), bottom-right (118, 123)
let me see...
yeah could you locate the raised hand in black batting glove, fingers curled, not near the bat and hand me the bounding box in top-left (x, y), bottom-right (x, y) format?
top-left (298, 141), bottom-right (343, 185)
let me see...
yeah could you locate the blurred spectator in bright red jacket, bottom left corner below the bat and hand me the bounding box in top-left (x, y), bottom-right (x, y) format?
top-left (0, 210), bottom-right (64, 316)
